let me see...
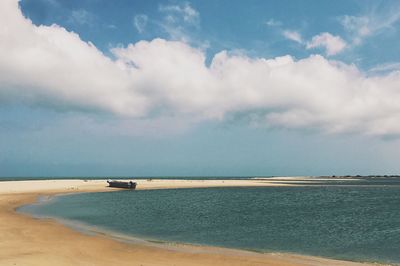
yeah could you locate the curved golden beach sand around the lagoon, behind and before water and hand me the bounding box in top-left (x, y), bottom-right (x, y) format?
top-left (0, 180), bottom-right (384, 266)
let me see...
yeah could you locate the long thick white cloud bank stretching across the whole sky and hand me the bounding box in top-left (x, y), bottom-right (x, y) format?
top-left (0, 0), bottom-right (400, 135)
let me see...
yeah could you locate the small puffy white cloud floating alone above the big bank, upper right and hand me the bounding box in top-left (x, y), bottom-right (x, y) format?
top-left (306, 32), bottom-right (347, 55)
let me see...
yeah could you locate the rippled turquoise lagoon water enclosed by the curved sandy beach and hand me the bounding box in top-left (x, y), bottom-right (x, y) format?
top-left (21, 186), bottom-right (400, 263)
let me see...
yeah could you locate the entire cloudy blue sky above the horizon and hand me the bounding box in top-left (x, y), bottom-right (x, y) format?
top-left (0, 0), bottom-right (400, 177)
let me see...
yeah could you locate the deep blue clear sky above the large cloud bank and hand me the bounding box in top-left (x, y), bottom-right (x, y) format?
top-left (20, 0), bottom-right (400, 70)
